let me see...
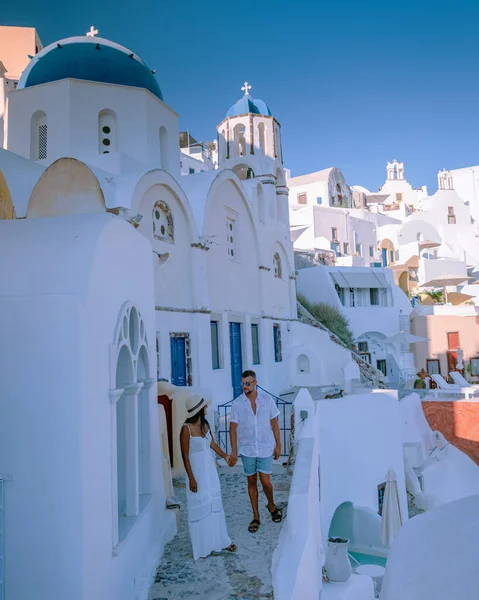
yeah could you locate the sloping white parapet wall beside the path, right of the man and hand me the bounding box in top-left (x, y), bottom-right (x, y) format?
top-left (271, 388), bottom-right (324, 600)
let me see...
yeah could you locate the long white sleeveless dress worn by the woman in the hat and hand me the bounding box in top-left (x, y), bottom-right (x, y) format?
top-left (186, 427), bottom-right (231, 560)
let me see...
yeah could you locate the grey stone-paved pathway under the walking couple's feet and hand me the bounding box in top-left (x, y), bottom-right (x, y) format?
top-left (149, 465), bottom-right (290, 600)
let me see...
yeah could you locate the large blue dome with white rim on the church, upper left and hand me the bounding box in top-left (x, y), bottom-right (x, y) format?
top-left (18, 37), bottom-right (163, 100)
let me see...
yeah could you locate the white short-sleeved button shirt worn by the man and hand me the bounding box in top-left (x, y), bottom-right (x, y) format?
top-left (230, 390), bottom-right (279, 458)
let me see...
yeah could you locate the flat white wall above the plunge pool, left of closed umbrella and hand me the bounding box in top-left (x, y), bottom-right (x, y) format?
top-left (318, 391), bottom-right (407, 546)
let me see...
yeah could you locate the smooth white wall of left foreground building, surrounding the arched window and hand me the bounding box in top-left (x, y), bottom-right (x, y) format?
top-left (0, 214), bottom-right (175, 600)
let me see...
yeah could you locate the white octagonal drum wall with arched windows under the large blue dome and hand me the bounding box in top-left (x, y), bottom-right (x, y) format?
top-left (7, 80), bottom-right (180, 177)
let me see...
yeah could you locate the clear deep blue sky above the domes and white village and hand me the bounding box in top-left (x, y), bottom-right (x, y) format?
top-left (0, 0), bottom-right (479, 193)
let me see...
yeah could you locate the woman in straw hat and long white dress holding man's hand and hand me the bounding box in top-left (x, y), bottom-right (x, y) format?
top-left (180, 395), bottom-right (236, 560)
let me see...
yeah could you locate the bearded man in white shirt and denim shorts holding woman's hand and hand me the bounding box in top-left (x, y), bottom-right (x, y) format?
top-left (229, 371), bottom-right (282, 533)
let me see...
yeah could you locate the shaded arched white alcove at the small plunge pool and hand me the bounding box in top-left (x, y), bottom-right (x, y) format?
top-left (329, 502), bottom-right (388, 557)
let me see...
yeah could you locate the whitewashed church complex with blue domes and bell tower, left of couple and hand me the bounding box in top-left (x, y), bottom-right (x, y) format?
top-left (0, 28), bottom-right (359, 600)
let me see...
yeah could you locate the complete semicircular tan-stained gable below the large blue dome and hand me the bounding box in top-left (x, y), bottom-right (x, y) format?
top-left (27, 158), bottom-right (106, 218)
